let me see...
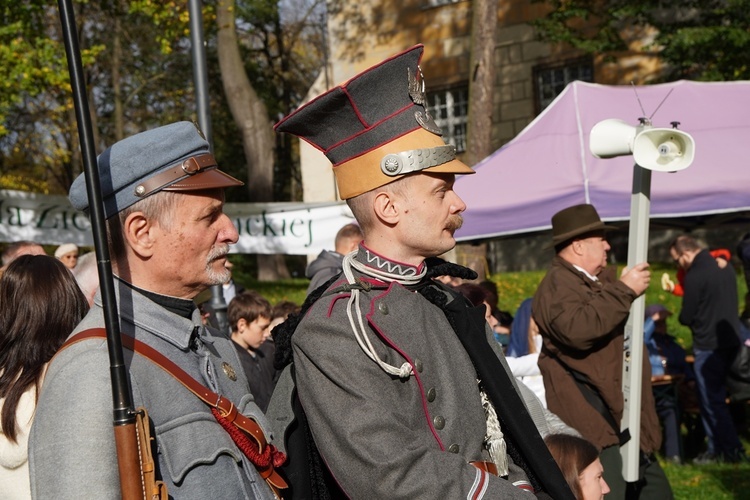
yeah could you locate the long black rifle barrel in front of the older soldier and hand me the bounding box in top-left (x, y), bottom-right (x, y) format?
top-left (58, 0), bottom-right (135, 426)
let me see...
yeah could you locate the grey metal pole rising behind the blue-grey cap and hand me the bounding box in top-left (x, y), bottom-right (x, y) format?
top-left (188, 0), bottom-right (229, 333)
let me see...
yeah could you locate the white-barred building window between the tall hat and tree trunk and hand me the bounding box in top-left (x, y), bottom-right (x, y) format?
top-left (428, 86), bottom-right (469, 153)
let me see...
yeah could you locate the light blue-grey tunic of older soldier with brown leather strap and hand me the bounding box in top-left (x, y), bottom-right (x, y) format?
top-left (29, 281), bottom-right (274, 500)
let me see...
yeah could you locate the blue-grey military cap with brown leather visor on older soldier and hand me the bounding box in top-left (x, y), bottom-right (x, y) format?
top-left (68, 121), bottom-right (243, 218)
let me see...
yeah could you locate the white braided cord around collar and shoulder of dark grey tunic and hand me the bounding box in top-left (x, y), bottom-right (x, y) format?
top-left (343, 250), bottom-right (427, 380)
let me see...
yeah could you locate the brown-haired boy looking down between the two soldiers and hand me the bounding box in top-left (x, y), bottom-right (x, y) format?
top-left (232, 290), bottom-right (274, 412)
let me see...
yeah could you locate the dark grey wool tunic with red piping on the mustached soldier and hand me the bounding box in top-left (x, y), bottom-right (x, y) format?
top-left (282, 248), bottom-right (543, 499)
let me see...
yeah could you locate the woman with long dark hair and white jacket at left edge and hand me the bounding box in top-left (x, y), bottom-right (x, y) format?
top-left (0, 255), bottom-right (89, 500)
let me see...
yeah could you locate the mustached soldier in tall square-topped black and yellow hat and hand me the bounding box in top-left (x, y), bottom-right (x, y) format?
top-left (268, 45), bottom-right (572, 499)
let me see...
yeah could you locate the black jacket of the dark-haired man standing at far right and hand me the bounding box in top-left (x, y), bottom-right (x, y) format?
top-left (679, 250), bottom-right (740, 351)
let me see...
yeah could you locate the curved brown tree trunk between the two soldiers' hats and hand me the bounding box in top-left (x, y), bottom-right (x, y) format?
top-left (216, 0), bottom-right (290, 281)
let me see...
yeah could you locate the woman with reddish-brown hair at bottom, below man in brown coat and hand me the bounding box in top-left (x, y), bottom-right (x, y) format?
top-left (544, 434), bottom-right (609, 500)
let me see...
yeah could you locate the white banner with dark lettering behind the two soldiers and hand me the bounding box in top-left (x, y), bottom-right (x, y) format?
top-left (0, 190), bottom-right (355, 255)
